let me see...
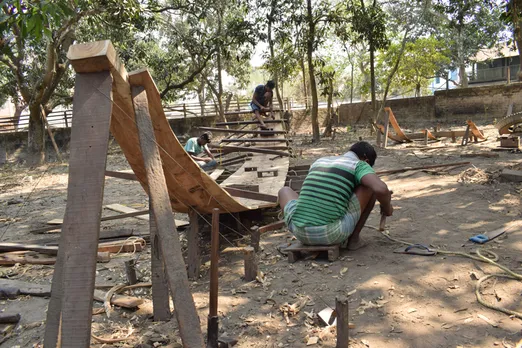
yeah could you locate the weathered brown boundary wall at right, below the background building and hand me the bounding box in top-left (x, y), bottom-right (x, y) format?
top-left (339, 83), bottom-right (522, 127)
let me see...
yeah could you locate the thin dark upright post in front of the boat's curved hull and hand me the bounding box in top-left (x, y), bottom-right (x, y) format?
top-left (207, 208), bottom-right (219, 348)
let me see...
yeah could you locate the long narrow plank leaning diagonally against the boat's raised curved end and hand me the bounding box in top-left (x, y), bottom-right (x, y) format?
top-left (132, 83), bottom-right (203, 348)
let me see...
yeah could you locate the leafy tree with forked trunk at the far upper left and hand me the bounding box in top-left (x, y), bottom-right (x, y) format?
top-left (0, 0), bottom-right (149, 164)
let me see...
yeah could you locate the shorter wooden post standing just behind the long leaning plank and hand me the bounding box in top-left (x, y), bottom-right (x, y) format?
top-left (149, 205), bottom-right (170, 321)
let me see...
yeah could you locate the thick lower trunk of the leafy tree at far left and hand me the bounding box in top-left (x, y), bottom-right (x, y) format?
top-left (27, 104), bottom-right (45, 166)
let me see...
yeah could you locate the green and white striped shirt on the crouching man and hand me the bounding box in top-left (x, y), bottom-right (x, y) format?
top-left (292, 151), bottom-right (375, 227)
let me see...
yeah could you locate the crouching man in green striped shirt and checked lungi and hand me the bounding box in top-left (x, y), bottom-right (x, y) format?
top-left (279, 141), bottom-right (393, 250)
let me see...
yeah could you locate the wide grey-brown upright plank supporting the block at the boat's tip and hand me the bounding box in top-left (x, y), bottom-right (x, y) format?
top-left (44, 72), bottom-right (112, 348)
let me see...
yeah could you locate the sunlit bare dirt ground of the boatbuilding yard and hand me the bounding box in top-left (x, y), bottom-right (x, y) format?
top-left (0, 119), bottom-right (522, 348)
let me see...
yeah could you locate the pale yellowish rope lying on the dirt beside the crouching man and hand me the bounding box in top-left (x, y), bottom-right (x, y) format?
top-left (366, 226), bottom-right (522, 319)
